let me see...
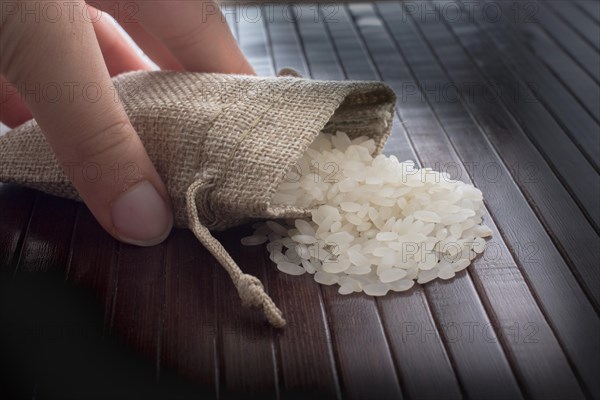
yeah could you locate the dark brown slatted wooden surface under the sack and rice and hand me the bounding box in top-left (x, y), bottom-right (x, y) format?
top-left (0, 0), bottom-right (600, 399)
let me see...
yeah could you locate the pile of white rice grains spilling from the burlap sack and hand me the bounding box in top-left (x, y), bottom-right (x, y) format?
top-left (242, 132), bottom-right (492, 296)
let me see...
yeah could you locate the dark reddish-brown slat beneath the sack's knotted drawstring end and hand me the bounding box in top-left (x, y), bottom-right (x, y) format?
top-left (213, 226), bottom-right (279, 399)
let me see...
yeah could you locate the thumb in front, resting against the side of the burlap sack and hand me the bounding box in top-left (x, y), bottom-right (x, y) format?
top-left (0, 1), bottom-right (173, 246)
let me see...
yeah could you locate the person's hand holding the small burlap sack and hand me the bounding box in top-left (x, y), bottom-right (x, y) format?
top-left (0, 0), bottom-right (254, 246)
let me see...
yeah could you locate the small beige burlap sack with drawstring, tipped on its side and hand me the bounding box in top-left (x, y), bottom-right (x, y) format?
top-left (0, 71), bottom-right (395, 327)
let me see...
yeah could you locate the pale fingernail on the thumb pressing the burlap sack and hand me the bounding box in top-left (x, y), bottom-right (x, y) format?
top-left (111, 181), bottom-right (173, 246)
